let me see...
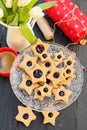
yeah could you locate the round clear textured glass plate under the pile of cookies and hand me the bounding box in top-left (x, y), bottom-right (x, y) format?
top-left (10, 43), bottom-right (84, 112)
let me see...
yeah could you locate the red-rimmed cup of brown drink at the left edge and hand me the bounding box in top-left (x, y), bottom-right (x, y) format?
top-left (0, 47), bottom-right (18, 77)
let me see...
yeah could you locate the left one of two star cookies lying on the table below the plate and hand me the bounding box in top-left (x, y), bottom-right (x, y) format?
top-left (15, 106), bottom-right (36, 127)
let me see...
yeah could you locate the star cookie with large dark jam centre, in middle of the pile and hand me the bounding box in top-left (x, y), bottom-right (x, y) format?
top-left (29, 64), bottom-right (46, 83)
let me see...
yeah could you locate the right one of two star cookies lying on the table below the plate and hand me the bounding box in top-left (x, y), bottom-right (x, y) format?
top-left (42, 111), bottom-right (60, 126)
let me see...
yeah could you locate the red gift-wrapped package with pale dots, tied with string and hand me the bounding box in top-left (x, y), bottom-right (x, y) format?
top-left (44, 0), bottom-right (87, 42)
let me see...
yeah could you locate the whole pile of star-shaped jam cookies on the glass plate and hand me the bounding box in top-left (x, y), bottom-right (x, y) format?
top-left (18, 39), bottom-right (76, 104)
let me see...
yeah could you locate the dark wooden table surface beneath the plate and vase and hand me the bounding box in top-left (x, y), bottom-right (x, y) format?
top-left (0, 0), bottom-right (87, 130)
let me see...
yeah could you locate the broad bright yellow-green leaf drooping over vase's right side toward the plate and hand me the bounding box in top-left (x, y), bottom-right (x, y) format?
top-left (19, 24), bottom-right (37, 44)
